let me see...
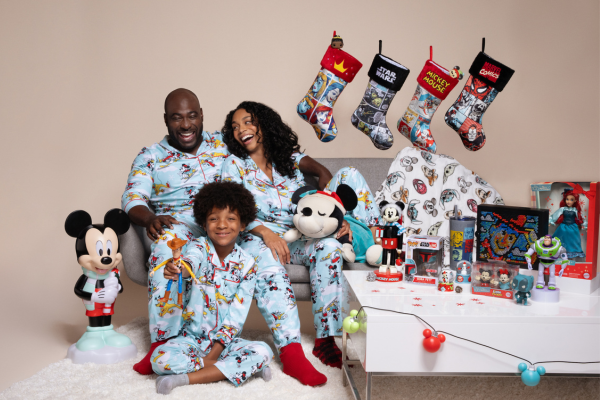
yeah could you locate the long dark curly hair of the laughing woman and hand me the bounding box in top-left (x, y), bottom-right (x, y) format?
top-left (222, 101), bottom-right (300, 178)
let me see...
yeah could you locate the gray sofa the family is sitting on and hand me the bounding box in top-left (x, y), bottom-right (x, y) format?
top-left (120, 158), bottom-right (393, 301)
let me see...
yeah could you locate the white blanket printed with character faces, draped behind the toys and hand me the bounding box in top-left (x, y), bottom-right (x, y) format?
top-left (375, 147), bottom-right (504, 265)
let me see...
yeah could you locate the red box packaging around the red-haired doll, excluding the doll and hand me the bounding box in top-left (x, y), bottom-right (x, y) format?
top-left (531, 182), bottom-right (600, 287)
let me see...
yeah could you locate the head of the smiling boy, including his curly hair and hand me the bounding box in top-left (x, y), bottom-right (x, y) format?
top-left (194, 182), bottom-right (256, 252)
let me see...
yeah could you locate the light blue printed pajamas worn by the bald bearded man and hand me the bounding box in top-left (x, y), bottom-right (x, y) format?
top-left (121, 132), bottom-right (229, 342)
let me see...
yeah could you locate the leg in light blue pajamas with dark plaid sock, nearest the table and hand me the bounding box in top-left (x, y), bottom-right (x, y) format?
top-left (289, 238), bottom-right (343, 368)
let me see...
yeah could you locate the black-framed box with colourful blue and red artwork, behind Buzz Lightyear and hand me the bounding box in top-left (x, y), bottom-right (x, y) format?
top-left (476, 204), bottom-right (549, 269)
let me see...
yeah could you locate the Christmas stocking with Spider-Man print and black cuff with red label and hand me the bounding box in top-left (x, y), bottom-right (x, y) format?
top-left (444, 42), bottom-right (515, 151)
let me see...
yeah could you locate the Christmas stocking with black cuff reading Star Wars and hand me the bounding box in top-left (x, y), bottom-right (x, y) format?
top-left (352, 53), bottom-right (410, 150)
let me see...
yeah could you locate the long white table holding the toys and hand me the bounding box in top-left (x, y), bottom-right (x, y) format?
top-left (342, 271), bottom-right (600, 400)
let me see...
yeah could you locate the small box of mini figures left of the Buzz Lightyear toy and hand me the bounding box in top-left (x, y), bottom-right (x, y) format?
top-left (471, 261), bottom-right (519, 299)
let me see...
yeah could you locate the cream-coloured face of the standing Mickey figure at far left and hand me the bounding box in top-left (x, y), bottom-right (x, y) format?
top-left (77, 228), bottom-right (122, 275)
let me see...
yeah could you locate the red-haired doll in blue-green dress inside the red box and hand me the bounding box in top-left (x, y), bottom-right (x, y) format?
top-left (550, 189), bottom-right (587, 259)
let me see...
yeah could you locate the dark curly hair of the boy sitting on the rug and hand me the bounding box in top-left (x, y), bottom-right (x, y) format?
top-left (194, 182), bottom-right (256, 226)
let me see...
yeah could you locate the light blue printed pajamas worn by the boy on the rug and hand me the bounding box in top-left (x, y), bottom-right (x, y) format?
top-left (151, 237), bottom-right (273, 386)
